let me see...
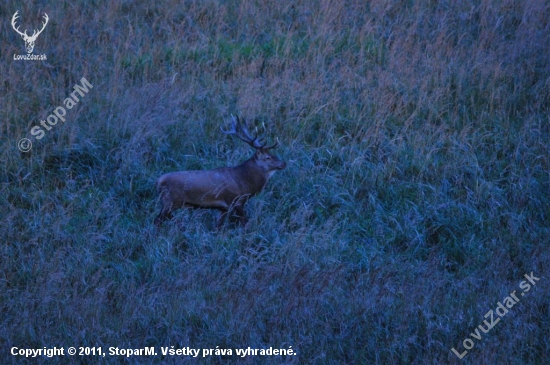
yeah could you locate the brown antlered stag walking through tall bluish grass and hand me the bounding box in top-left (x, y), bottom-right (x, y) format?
top-left (154, 116), bottom-right (286, 229)
